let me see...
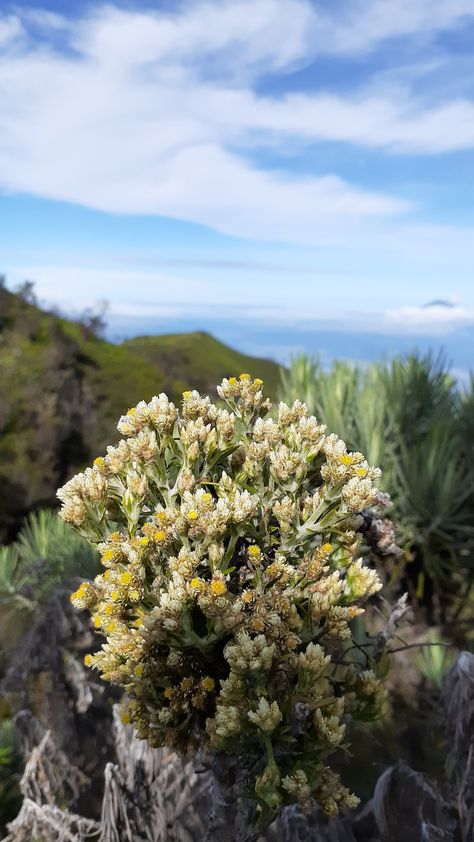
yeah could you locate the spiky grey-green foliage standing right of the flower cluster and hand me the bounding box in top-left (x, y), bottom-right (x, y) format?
top-left (280, 354), bottom-right (474, 619)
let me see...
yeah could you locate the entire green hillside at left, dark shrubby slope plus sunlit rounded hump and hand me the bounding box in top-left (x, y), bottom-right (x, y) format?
top-left (0, 286), bottom-right (279, 540)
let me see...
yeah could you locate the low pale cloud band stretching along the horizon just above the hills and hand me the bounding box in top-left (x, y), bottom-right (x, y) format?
top-left (10, 266), bottom-right (474, 337)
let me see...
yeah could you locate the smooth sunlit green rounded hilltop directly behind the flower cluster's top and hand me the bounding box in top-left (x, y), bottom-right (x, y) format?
top-left (122, 331), bottom-right (280, 397)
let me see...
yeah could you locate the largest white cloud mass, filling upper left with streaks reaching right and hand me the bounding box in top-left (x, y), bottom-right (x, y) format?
top-left (0, 0), bottom-right (474, 244)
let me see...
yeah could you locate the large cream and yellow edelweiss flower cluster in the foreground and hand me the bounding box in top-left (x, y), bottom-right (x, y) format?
top-left (58, 374), bottom-right (381, 815)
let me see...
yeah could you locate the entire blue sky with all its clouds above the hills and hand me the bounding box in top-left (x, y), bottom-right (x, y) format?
top-left (0, 0), bottom-right (474, 367)
